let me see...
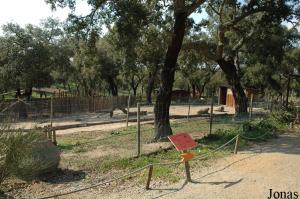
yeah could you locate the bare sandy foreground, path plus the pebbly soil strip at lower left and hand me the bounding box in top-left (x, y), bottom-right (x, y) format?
top-left (1, 131), bottom-right (300, 199)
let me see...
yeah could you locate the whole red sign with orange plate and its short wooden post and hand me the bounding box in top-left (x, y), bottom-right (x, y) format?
top-left (168, 133), bottom-right (197, 182)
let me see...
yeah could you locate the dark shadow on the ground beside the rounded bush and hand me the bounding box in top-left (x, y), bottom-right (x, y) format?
top-left (39, 169), bottom-right (86, 184)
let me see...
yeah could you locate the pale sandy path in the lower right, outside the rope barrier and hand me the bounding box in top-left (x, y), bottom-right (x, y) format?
top-left (98, 133), bottom-right (300, 199)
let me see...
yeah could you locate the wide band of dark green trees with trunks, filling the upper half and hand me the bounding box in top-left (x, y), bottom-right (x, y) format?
top-left (0, 0), bottom-right (299, 140)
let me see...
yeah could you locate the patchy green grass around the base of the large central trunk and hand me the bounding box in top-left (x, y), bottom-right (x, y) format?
top-left (58, 110), bottom-right (287, 182)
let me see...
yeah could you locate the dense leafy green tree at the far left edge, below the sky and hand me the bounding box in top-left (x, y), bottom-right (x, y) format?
top-left (0, 20), bottom-right (65, 98)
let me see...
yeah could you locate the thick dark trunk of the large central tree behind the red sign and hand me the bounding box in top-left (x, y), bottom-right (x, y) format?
top-left (154, 12), bottom-right (187, 140)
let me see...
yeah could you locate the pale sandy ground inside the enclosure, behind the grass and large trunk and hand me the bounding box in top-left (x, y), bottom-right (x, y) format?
top-left (13, 105), bottom-right (263, 134)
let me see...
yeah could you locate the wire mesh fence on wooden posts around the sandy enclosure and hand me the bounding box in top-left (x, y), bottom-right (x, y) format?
top-left (0, 96), bottom-right (298, 159)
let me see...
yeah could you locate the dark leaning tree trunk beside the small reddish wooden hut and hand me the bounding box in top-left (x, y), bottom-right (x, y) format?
top-left (217, 58), bottom-right (248, 115)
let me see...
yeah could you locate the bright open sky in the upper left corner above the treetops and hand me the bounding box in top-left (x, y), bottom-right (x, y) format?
top-left (0, 0), bottom-right (90, 26)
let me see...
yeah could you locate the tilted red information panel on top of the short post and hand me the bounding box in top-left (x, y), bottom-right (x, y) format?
top-left (168, 133), bottom-right (197, 151)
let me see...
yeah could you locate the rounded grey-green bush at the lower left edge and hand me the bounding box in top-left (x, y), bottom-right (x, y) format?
top-left (0, 127), bottom-right (60, 182)
